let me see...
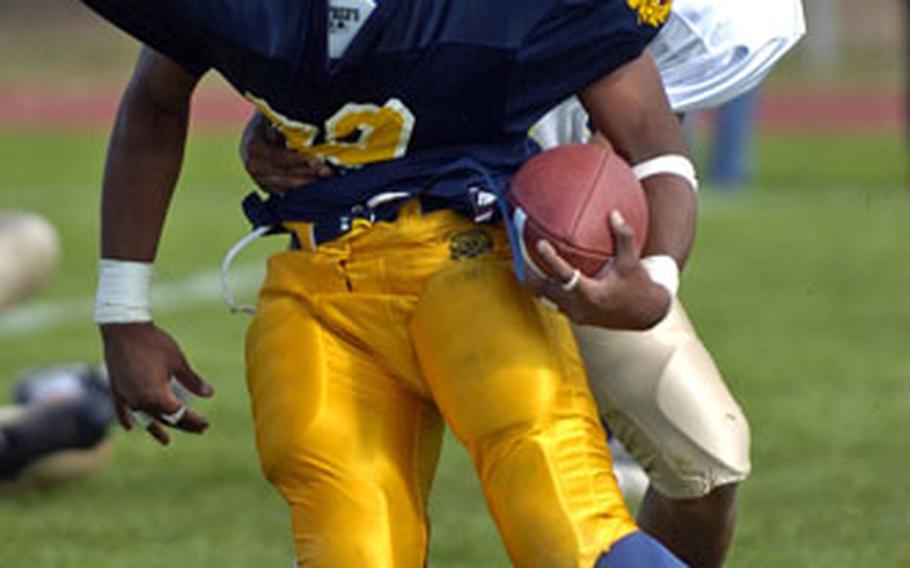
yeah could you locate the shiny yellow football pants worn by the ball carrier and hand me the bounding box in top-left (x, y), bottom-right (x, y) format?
top-left (246, 204), bottom-right (636, 568)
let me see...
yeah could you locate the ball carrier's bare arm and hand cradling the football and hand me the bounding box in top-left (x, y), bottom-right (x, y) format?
top-left (529, 54), bottom-right (696, 330)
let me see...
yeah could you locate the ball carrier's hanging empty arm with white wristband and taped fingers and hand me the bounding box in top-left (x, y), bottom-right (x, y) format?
top-left (96, 49), bottom-right (212, 444)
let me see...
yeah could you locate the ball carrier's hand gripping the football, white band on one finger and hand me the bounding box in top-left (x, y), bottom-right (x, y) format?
top-left (527, 211), bottom-right (671, 330)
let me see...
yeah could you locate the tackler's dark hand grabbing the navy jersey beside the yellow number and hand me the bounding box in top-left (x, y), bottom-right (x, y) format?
top-left (240, 112), bottom-right (333, 193)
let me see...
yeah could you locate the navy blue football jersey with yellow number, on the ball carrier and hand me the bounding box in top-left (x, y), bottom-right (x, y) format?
top-left (84, 0), bottom-right (670, 233)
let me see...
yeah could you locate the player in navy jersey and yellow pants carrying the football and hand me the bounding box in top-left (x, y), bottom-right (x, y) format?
top-left (85, 0), bottom-right (695, 566)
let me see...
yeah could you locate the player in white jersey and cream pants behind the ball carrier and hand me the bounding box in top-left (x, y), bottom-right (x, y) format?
top-left (241, 0), bottom-right (805, 566)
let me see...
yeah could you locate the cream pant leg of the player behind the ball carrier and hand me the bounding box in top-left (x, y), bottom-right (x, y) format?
top-left (575, 304), bottom-right (750, 499)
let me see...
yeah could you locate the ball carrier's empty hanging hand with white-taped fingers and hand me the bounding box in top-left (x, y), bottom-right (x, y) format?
top-left (101, 322), bottom-right (214, 445)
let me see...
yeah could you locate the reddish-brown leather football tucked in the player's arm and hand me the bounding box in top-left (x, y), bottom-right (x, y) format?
top-left (508, 144), bottom-right (648, 277)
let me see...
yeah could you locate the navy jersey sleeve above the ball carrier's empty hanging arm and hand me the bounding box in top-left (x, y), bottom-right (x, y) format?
top-left (83, 0), bottom-right (211, 77)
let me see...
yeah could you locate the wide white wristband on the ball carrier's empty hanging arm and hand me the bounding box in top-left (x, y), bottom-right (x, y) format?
top-left (95, 259), bottom-right (152, 324)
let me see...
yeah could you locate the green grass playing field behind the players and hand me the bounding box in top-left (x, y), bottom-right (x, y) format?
top-left (0, 125), bottom-right (910, 568)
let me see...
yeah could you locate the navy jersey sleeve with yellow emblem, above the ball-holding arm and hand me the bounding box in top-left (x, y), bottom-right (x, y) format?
top-left (508, 0), bottom-right (670, 126)
